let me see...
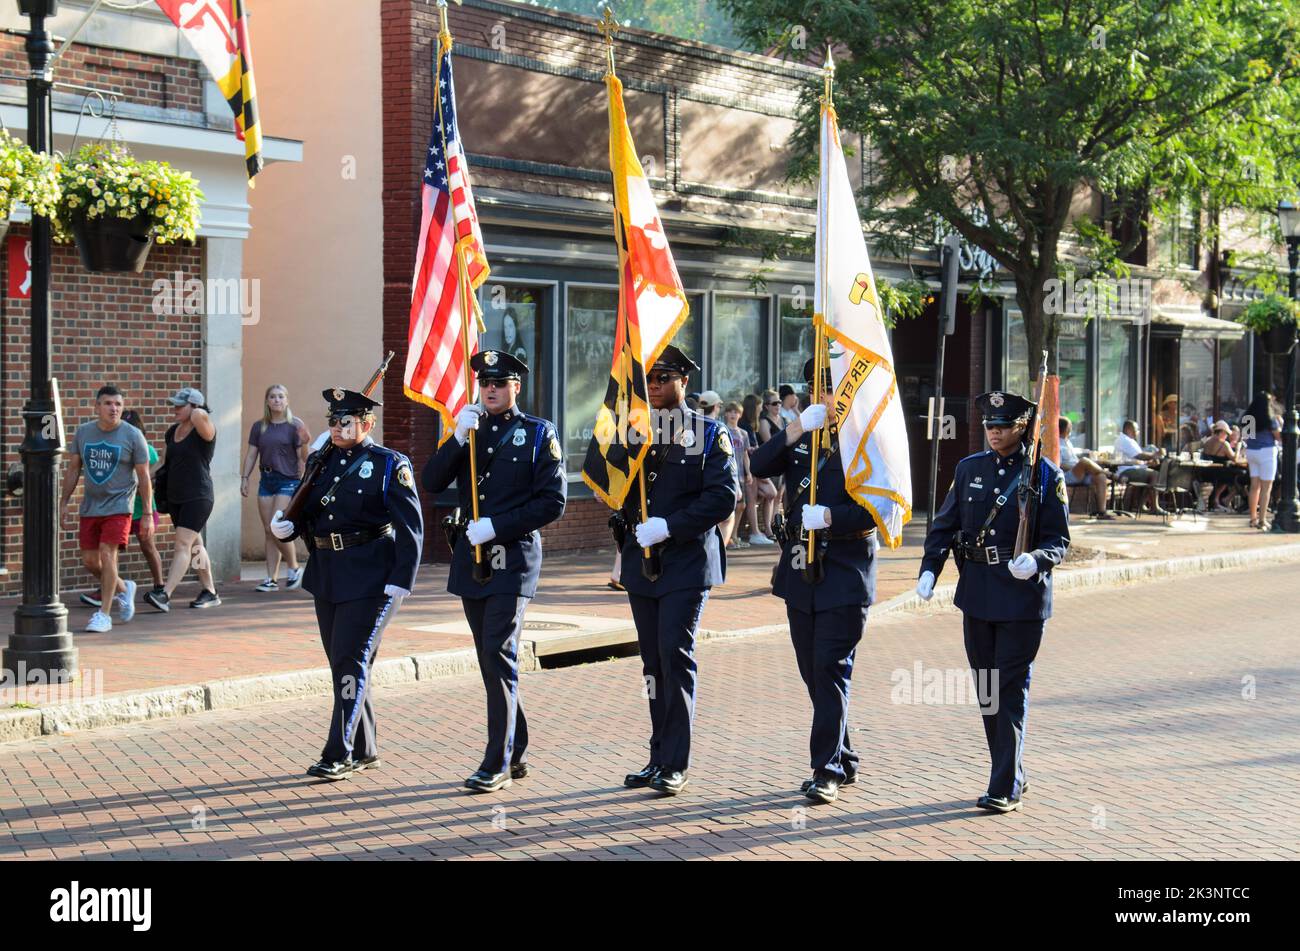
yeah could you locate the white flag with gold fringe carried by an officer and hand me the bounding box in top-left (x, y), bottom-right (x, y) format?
top-left (813, 103), bottom-right (911, 548)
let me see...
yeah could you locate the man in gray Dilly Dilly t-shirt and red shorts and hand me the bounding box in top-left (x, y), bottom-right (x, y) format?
top-left (60, 386), bottom-right (153, 633)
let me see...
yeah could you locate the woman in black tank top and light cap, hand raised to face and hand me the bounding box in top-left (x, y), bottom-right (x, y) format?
top-left (144, 386), bottom-right (221, 611)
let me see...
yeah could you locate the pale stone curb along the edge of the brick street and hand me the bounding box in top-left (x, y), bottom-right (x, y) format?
top-left (0, 544), bottom-right (1300, 743)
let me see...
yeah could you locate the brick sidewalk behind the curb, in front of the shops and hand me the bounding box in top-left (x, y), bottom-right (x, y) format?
top-left (0, 516), bottom-right (1295, 709)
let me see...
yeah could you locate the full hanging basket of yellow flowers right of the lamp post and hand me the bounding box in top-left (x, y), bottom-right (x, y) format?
top-left (53, 143), bottom-right (203, 273)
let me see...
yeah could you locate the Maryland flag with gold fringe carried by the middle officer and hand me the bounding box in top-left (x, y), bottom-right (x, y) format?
top-left (582, 74), bottom-right (689, 508)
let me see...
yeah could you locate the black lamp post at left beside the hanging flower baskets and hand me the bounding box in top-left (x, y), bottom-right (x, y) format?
top-left (0, 0), bottom-right (77, 683)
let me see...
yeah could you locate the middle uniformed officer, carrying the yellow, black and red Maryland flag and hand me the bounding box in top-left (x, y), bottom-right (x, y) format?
top-left (620, 346), bottom-right (736, 795)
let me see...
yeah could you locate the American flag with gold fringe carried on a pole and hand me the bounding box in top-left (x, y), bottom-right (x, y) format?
top-left (403, 32), bottom-right (489, 439)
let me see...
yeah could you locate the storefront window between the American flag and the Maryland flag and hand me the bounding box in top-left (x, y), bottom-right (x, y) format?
top-left (564, 286), bottom-right (619, 476)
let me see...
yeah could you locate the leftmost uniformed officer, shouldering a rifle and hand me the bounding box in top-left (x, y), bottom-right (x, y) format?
top-left (270, 388), bottom-right (424, 781)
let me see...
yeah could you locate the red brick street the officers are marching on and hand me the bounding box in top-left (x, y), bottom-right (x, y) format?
top-left (0, 564), bottom-right (1300, 860)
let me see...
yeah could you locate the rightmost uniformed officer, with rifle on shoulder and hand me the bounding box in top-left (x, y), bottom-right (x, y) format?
top-left (917, 392), bottom-right (1070, 812)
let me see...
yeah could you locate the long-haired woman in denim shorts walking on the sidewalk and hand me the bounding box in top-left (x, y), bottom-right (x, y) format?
top-left (239, 383), bottom-right (312, 591)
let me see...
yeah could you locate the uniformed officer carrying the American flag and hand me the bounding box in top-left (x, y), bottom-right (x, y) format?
top-left (421, 349), bottom-right (567, 793)
